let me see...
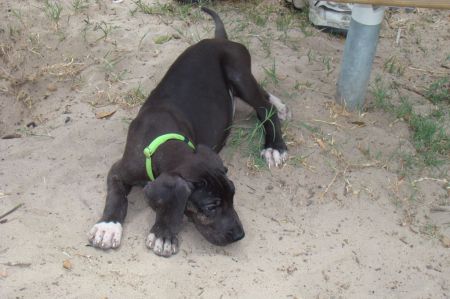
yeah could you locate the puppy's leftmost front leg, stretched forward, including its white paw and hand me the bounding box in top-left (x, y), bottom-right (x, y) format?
top-left (88, 161), bottom-right (131, 249)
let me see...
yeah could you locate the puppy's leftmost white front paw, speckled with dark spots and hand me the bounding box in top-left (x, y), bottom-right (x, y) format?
top-left (88, 222), bottom-right (122, 249)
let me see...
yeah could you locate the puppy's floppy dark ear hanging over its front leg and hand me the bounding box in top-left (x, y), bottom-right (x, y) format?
top-left (144, 174), bottom-right (192, 210)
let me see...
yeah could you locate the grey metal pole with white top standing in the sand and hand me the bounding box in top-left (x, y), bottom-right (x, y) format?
top-left (336, 4), bottom-right (384, 110)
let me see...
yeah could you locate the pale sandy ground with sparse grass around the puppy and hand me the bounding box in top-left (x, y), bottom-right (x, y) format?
top-left (0, 0), bottom-right (450, 298)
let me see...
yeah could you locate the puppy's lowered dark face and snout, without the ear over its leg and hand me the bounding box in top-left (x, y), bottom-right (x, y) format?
top-left (178, 145), bottom-right (245, 246)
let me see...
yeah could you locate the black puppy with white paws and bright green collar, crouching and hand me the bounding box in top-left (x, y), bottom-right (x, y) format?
top-left (89, 8), bottom-right (287, 256)
